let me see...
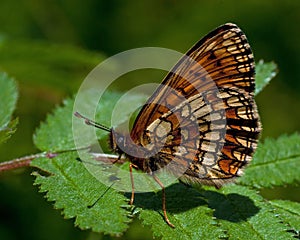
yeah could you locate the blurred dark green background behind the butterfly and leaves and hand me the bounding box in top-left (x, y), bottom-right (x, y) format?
top-left (0, 0), bottom-right (300, 240)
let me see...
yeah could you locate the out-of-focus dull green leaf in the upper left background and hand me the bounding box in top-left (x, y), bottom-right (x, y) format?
top-left (0, 39), bottom-right (103, 93)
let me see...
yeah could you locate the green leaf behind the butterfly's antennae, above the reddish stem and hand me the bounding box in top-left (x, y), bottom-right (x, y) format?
top-left (34, 91), bottom-right (145, 151)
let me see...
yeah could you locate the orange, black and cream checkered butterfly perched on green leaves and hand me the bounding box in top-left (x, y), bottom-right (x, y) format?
top-left (75, 23), bottom-right (261, 227)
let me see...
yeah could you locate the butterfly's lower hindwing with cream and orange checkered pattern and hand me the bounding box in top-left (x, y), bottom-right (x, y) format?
top-left (142, 89), bottom-right (260, 185)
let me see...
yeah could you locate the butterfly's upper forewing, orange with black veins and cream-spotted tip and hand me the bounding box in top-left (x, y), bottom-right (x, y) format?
top-left (131, 24), bottom-right (254, 143)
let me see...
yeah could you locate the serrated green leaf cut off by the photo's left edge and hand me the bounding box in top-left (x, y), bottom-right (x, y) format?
top-left (0, 73), bottom-right (18, 143)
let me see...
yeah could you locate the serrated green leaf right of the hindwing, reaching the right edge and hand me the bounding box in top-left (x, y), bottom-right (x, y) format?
top-left (239, 133), bottom-right (300, 188)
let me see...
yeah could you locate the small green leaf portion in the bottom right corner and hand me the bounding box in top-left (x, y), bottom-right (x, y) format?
top-left (270, 200), bottom-right (300, 238)
